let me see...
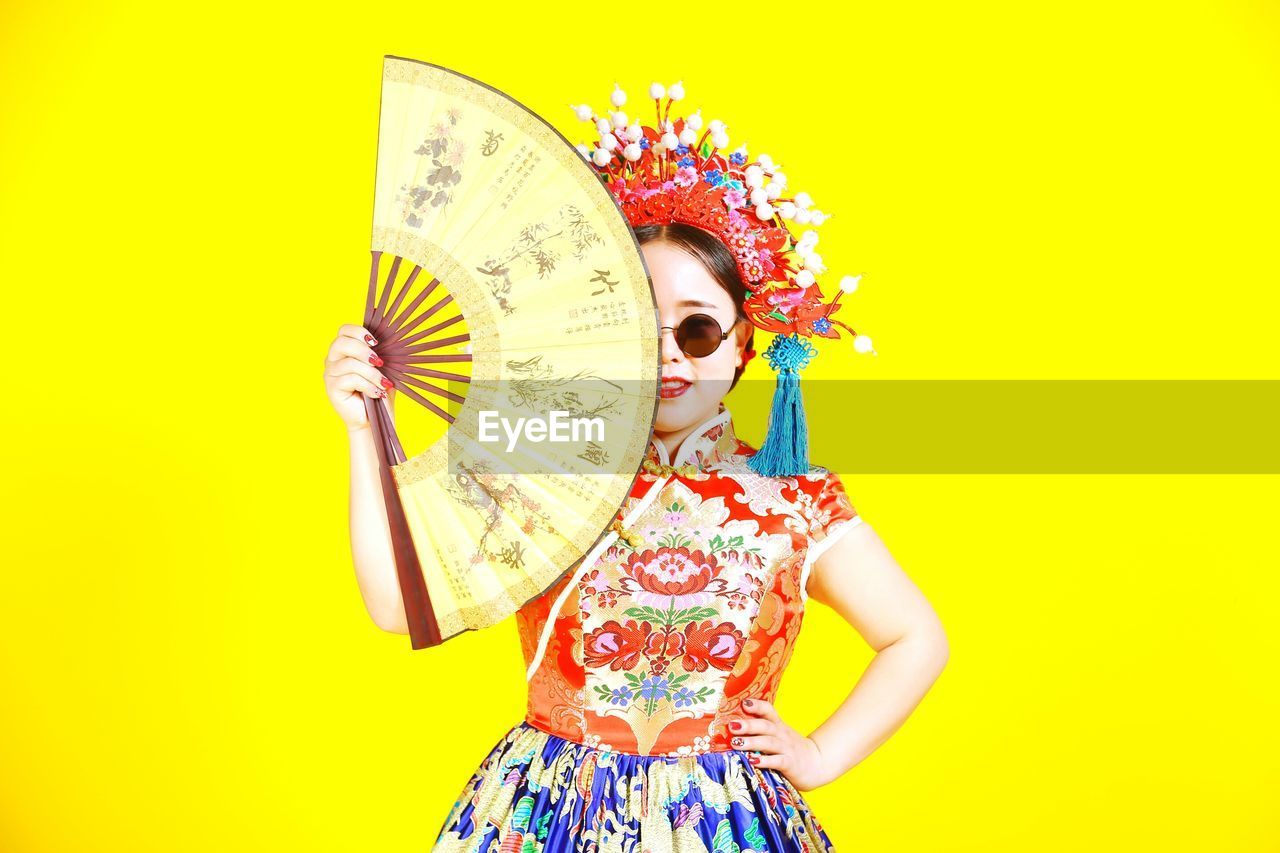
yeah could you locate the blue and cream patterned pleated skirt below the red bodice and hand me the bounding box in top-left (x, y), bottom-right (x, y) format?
top-left (431, 720), bottom-right (835, 853)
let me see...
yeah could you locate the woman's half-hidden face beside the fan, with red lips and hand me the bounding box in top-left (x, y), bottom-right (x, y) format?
top-left (640, 241), bottom-right (746, 433)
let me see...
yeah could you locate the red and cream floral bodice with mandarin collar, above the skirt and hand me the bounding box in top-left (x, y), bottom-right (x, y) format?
top-left (516, 403), bottom-right (861, 756)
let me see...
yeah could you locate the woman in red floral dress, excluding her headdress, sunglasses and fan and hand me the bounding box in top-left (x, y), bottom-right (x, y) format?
top-left (325, 224), bottom-right (947, 852)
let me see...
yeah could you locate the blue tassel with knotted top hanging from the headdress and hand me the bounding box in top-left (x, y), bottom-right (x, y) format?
top-left (746, 334), bottom-right (818, 476)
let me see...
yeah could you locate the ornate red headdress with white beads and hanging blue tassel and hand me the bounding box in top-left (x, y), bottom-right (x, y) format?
top-left (572, 76), bottom-right (876, 476)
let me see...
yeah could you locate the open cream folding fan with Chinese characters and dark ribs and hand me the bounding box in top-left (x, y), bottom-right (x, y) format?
top-left (364, 56), bottom-right (660, 649)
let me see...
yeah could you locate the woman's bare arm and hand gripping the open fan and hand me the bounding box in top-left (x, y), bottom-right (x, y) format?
top-left (324, 323), bottom-right (408, 634)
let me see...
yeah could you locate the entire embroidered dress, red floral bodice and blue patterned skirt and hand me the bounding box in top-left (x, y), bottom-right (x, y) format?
top-left (433, 403), bottom-right (861, 853)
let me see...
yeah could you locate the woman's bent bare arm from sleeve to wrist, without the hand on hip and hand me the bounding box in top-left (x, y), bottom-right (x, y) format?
top-left (808, 524), bottom-right (950, 784)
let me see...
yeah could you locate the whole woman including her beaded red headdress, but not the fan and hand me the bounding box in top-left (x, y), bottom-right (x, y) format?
top-left (325, 83), bottom-right (948, 853)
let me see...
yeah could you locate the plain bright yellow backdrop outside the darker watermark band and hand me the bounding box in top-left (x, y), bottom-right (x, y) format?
top-left (0, 0), bottom-right (1280, 853)
